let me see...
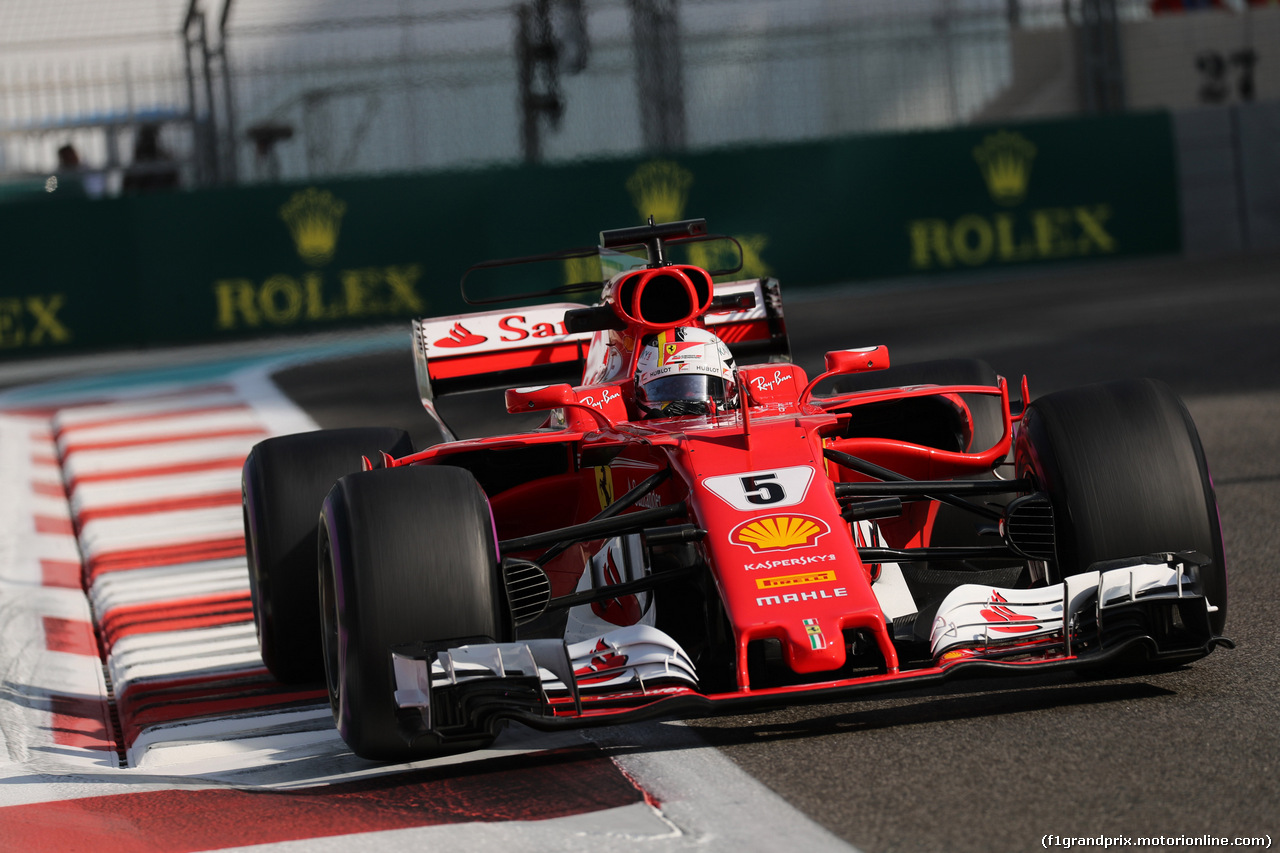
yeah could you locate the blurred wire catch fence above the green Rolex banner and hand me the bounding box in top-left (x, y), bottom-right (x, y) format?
top-left (0, 0), bottom-right (1259, 195)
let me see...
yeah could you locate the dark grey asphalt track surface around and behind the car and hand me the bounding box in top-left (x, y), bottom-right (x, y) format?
top-left (276, 256), bottom-right (1280, 852)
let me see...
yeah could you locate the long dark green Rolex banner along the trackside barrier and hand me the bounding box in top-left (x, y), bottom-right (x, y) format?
top-left (0, 113), bottom-right (1180, 355)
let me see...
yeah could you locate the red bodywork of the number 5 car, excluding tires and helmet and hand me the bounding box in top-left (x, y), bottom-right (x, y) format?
top-left (345, 220), bottom-right (1226, 727)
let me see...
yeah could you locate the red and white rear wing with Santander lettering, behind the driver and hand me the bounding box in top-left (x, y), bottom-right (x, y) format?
top-left (413, 278), bottom-right (791, 420)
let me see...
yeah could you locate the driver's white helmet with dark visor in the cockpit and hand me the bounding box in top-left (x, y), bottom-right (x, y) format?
top-left (635, 327), bottom-right (737, 418)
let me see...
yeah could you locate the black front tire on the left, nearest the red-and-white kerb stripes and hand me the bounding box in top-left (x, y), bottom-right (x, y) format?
top-left (320, 466), bottom-right (512, 761)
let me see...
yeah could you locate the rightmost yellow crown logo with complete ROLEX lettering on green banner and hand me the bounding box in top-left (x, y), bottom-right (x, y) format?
top-left (906, 131), bottom-right (1119, 270)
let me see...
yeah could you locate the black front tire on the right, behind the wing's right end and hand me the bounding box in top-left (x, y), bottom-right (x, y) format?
top-left (1014, 379), bottom-right (1226, 634)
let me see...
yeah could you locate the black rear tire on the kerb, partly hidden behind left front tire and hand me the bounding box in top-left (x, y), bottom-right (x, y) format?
top-left (241, 428), bottom-right (413, 684)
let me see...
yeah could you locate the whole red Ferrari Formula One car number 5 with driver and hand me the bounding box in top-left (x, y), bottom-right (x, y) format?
top-left (244, 220), bottom-right (1230, 761)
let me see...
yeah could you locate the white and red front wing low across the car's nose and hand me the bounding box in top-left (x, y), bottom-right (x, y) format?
top-left (392, 552), bottom-right (1233, 743)
